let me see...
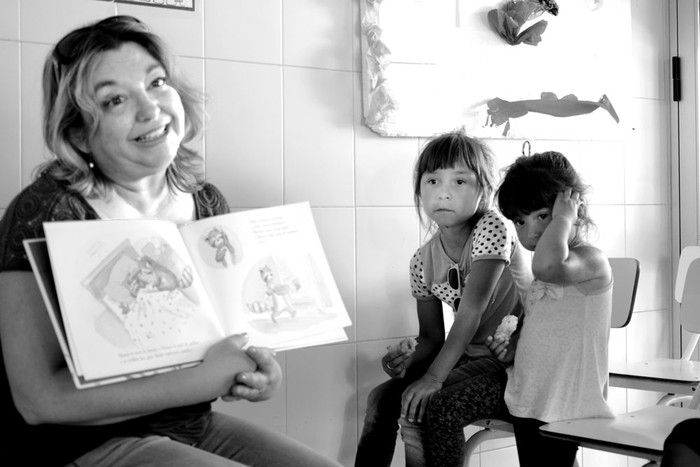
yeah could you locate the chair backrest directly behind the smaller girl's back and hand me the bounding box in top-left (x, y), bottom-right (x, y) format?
top-left (608, 258), bottom-right (639, 328)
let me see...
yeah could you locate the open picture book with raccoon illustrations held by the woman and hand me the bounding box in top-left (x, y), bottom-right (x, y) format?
top-left (24, 203), bottom-right (351, 388)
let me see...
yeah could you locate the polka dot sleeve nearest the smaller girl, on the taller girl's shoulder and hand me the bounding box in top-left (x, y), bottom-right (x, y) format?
top-left (471, 211), bottom-right (516, 264)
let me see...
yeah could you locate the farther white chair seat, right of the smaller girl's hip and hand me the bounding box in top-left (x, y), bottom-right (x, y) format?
top-left (609, 358), bottom-right (700, 395)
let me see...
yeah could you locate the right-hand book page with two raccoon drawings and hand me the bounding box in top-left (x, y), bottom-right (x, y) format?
top-left (181, 203), bottom-right (351, 350)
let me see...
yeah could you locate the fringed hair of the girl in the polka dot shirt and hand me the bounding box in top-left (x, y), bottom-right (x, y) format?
top-left (413, 131), bottom-right (498, 224)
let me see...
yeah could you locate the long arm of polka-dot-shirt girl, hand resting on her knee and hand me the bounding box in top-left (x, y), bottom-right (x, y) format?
top-left (401, 259), bottom-right (506, 423)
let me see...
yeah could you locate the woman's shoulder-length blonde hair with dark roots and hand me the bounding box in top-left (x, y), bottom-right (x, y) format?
top-left (39, 16), bottom-right (204, 197)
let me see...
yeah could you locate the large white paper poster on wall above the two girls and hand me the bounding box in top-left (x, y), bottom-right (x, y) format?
top-left (360, 0), bottom-right (631, 139)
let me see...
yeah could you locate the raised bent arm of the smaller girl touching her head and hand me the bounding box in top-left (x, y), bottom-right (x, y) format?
top-left (532, 188), bottom-right (611, 288)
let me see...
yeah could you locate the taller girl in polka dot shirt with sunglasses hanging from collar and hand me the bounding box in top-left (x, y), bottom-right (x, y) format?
top-left (355, 132), bottom-right (531, 467)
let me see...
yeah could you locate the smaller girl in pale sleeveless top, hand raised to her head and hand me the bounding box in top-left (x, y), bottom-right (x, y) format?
top-left (490, 152), bottom-right (613, 466)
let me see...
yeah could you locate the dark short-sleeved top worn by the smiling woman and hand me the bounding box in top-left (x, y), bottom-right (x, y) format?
top-left (0, 173), bottom-right (229, 466)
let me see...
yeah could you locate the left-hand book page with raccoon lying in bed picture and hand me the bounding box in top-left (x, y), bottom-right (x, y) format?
top-left (44, 219), bottom-right (223, 380)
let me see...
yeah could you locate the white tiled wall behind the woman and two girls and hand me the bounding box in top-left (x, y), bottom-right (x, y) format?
top-left (0, 0), bottom-right (671, 467)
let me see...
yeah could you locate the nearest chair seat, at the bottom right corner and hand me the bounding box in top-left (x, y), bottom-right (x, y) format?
top-left (540, 405), bottom-right (700, 461)
